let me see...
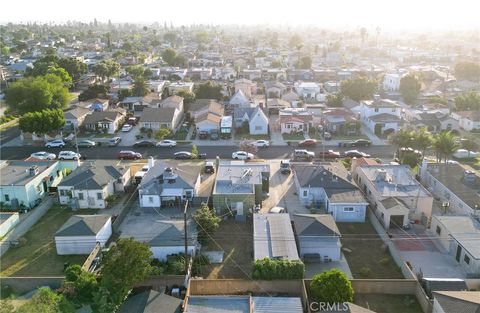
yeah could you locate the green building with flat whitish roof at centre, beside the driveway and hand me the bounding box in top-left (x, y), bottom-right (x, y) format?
top-left (212, 161), bottom-right (270, 216)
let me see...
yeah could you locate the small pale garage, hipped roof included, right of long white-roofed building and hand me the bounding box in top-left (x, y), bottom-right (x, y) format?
top-left (293, 214), bottom-right (342, 262)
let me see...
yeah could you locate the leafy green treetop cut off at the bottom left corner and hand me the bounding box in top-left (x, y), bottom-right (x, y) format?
top-left (17, 287), bottom-right (75, 313)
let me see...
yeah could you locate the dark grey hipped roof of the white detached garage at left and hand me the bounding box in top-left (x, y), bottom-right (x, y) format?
top-left (55, 215), bottom-right (111, 237)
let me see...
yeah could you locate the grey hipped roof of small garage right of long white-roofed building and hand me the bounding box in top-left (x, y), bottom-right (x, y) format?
top-left (293, 214), bottom-right (341, 237)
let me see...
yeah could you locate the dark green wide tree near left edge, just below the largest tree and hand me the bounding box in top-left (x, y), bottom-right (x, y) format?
top-left (18, 109), bottom-right (65, 135)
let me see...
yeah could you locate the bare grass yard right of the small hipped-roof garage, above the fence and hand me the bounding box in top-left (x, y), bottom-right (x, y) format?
top-left (337, 221), bottom-right (404, 278)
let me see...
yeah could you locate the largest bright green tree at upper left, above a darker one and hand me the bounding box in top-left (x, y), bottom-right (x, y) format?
top-left (5, 74), bottom-right (68, 114)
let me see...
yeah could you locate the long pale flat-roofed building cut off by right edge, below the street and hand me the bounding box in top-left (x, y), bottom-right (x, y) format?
top-left (420, 160), bottom-right (480, 215)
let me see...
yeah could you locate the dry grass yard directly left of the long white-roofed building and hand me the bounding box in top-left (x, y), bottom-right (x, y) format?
top-left (197, 220), bottom-right (253, 279)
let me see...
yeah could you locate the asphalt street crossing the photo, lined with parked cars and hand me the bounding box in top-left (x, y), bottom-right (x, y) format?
top-left (0, 145), bottom-right (395, 161)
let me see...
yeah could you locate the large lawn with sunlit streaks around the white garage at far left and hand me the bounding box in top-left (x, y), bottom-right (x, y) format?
top-left (0, 206), bottom-right (98, 277)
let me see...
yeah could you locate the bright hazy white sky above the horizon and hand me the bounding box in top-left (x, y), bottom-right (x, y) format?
top-left (0, 0), bottom-right (480, 30)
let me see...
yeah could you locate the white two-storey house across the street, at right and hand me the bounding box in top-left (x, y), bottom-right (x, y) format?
top-left (360, 99), bottom-right (404, 134)
